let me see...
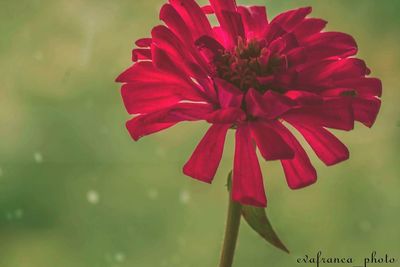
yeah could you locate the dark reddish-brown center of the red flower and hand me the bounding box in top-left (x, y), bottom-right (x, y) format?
top-left (214, 39), bottom-right (286, 93)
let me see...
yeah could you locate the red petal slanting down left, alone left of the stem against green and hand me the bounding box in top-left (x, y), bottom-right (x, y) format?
top-left (183, 124), bottom-right (230, 183)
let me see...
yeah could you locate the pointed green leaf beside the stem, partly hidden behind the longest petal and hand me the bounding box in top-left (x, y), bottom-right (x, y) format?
top-left (227, 171), bottom-right (290, 253)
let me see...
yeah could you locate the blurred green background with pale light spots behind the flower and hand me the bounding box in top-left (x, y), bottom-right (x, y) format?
top-left (0, 0), bottom-right (400, 267)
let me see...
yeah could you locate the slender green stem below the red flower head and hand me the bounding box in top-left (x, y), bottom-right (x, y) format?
top-left (219, 194), bottom-right (242, 267)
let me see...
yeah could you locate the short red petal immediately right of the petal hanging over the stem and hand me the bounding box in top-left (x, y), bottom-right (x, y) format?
top-left (250, 122), bottom-right (294, 160)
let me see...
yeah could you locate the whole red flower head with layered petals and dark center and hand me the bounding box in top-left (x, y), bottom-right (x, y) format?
top-left (117, 0), bottom-right (382, 206)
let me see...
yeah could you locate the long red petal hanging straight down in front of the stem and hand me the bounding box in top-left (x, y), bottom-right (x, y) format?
top-left (232, 124), bottom-right (267, 207)
